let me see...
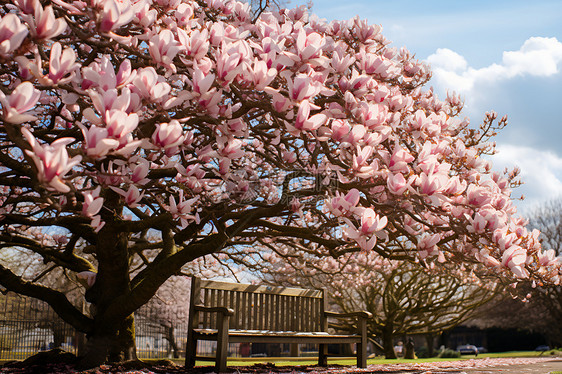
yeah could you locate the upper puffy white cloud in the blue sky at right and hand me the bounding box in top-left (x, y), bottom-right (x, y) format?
top-left (427, 37), bottom-right (562, 96)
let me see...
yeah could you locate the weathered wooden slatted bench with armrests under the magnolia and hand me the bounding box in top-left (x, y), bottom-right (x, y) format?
top-left (185, 277), bottom-right (372, 372)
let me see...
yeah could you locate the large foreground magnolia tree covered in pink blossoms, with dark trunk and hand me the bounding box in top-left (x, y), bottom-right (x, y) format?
top-left (0, 0), bottom-right (560, 366)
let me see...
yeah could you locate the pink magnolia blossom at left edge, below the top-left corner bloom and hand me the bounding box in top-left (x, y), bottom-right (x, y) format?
top-left (0, 82), bottom-right (41, 124)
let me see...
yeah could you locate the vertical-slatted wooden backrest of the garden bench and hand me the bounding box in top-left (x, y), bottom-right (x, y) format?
top-left (189, 277), bottom-right (327, 332)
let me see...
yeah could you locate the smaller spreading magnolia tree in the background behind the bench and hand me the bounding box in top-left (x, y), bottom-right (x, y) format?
top-left (251, 248), bottom-right (496, 359)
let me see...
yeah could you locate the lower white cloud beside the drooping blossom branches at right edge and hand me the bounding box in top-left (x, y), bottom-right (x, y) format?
top-left (491, 145), bottom-right (562, 212)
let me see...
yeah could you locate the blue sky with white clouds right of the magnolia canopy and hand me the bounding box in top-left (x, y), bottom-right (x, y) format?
top-left (290, 0), bottom-right (562, 213)
